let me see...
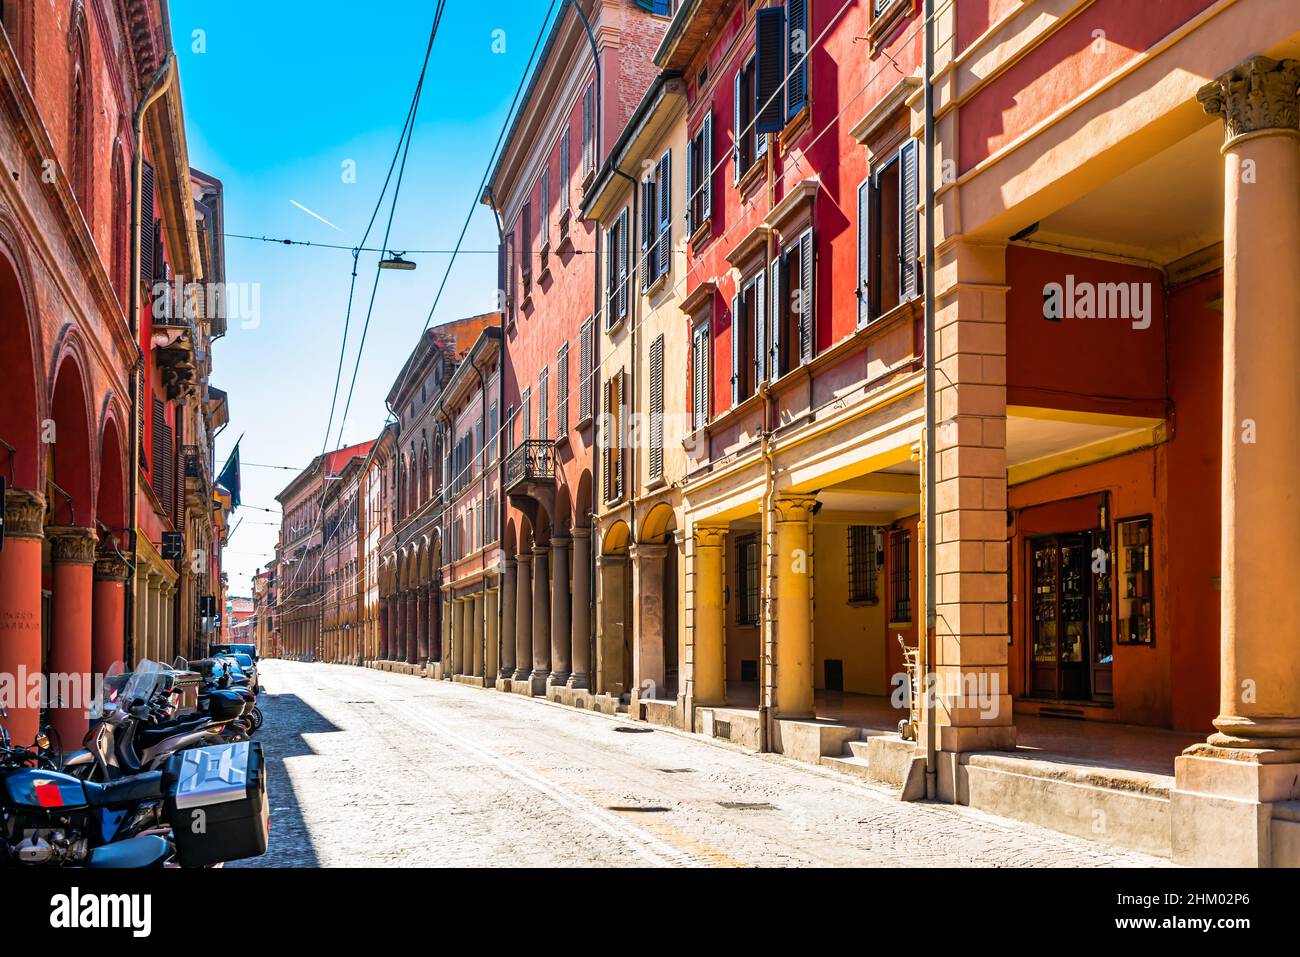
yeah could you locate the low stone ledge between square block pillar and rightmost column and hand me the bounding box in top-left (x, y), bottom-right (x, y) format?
top-left (956, 752), bottom-right (1174, 857)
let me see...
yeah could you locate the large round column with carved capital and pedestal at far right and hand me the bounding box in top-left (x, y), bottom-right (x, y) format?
top-left (1170, 56), bottom-right (1300, 867)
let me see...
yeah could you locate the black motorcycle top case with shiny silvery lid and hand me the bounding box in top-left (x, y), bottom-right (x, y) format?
top-left (165, 741), bottom-right (269, 867)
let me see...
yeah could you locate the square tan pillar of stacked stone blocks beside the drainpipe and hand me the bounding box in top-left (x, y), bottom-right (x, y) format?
top-left (935, 239), bottom-right (1015, 754)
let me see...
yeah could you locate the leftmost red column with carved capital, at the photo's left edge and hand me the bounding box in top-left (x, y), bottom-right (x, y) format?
top-left (0, 489), bottom-right (45, 748)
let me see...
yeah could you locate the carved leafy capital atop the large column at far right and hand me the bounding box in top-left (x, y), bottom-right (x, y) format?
top-left (1196, 56), bottom-right (1300, 150)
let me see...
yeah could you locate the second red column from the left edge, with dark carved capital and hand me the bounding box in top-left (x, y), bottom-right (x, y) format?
top-left (47, 527), bottom-right (95, 750)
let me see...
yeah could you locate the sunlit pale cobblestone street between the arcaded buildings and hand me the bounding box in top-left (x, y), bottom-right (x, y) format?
top-left (243, 661), bottom-right (1165, 867)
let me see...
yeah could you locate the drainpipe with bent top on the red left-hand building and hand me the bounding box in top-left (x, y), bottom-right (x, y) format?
top-left (122, 53), bottom-right (176, 667)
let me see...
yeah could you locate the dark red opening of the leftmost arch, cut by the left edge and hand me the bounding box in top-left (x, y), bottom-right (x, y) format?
top-left (0, 227), bottom-right (46, 490)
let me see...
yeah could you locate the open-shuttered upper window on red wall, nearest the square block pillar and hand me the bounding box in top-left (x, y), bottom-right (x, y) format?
top-left (857, 140), bottom-right (924, 325)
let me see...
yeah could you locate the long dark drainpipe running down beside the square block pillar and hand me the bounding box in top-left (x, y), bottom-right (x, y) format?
top-left (922, 0), bottom-right (939, 801)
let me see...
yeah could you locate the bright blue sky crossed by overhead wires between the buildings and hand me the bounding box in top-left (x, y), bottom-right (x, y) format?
top-left (170, 0), bottom-right (550, 594)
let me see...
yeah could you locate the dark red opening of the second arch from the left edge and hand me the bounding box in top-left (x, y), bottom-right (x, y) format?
top-left (46, 343), bottom-right (95, 525)
